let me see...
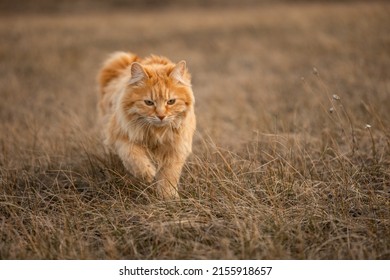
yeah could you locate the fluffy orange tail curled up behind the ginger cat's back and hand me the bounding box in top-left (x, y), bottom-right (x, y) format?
top-left (98, 52), bottom-right (139, 95)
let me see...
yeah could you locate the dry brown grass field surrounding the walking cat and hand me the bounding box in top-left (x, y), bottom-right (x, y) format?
top-left (0, 1), bottom-right (390, 259)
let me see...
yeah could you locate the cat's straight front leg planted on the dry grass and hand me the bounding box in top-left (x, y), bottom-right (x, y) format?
top-left (156, 160), bottom-right (184, 199)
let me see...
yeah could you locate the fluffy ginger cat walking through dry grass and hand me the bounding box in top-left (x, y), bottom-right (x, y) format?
top-left (99, 52), bottom-right (196, 199)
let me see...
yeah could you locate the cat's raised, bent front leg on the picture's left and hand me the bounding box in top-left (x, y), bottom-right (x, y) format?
top-left (117, 142), bottom-right (156, 183)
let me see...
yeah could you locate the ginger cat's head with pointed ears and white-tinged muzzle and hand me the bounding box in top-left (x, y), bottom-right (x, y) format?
top-left (120, 61), bottom-right (194, 127)
